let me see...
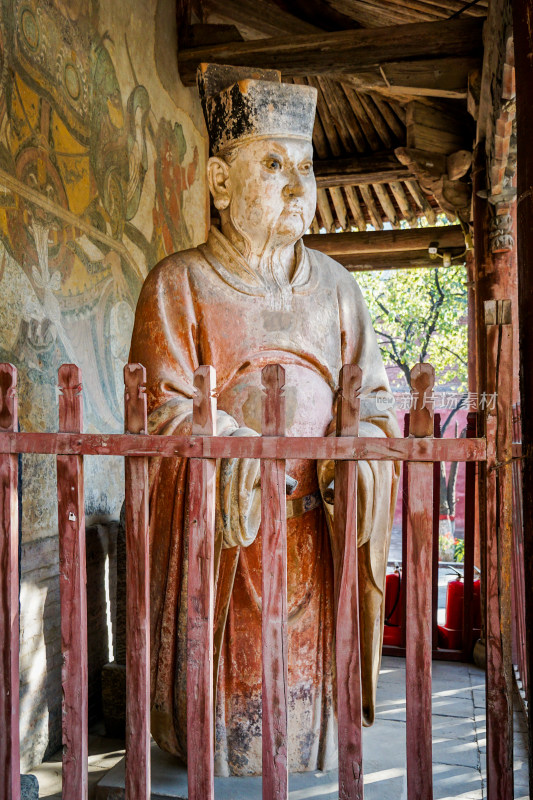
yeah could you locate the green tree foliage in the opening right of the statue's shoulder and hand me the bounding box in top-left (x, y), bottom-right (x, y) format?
top-left (357, 265), bottom-right (468, 392)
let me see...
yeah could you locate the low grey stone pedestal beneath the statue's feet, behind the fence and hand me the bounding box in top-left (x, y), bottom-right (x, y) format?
top-left (95, 742), bottom-right (339, 800)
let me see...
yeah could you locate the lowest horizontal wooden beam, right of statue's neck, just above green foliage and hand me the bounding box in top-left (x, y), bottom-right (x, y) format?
top-left (304, 225), bottom-right (465, 266)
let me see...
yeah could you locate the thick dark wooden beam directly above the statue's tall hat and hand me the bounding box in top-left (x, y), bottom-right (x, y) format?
top-left (178, 18), bottom-right (482, 86)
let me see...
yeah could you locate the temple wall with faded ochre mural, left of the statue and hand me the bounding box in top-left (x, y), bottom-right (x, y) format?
top-left (0, 0), bottom-right (207, 769)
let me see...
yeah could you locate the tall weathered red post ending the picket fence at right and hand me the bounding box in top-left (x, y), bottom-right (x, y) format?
top-left (482, 300), bottom-right (513, 800)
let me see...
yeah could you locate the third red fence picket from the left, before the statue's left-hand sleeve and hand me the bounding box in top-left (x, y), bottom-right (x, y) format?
top-left (124, 364), bottom-right (151, 800)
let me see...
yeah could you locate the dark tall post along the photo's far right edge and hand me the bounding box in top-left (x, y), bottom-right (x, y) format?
top-left (512, 0), bottom-right (533, 796)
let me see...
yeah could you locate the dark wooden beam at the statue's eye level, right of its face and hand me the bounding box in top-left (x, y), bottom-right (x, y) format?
top-left (314, 150), bottom-right (413, 188)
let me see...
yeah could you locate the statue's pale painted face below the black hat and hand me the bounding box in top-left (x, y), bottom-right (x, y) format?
top-left (210, 138), bottom-right (316, 251)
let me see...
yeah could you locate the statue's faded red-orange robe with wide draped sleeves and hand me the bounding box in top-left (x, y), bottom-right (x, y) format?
top-left (130, 229), bottom-right (399, 775)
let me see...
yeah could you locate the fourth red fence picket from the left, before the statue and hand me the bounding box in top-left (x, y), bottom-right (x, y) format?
top-left (187, 366), bottom-right (216, 800)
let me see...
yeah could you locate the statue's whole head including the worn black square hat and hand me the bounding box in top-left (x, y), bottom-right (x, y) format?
top-left (198, 65), bottom-right (316, 250)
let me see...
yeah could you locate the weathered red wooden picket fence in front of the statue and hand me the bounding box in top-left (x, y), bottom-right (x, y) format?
top-left (0, 301), bottom-right (512, 800)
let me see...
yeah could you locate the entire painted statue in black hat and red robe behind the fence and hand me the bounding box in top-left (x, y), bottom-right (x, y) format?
top-left (130, 65), bottom-right (399, 775)
